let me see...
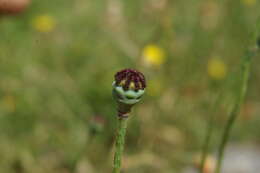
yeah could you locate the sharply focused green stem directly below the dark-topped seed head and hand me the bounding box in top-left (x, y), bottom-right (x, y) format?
top-left (113, 117), bottom-right (128, 173)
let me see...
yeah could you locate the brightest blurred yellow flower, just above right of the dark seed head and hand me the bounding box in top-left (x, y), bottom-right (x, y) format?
top-left (142, 44), bottom-right (166, 66)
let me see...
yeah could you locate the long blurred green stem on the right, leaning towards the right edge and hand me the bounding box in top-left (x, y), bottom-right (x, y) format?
top-left (215, 49), bottom-right (256, 173)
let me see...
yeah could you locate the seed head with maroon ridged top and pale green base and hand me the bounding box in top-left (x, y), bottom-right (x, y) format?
top-left (112, 69), bottom-right (146, 116)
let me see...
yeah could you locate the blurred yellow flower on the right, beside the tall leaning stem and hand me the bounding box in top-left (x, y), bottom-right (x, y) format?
top-left (208, 58), bottom-right (227, 80)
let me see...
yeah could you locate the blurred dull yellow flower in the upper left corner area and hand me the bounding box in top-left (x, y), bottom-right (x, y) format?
top-left (32, 15), bottom-right (56, 33)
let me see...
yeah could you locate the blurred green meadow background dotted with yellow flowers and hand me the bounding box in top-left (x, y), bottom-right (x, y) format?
top-left (0, 0), bottom-right (260, 173)
